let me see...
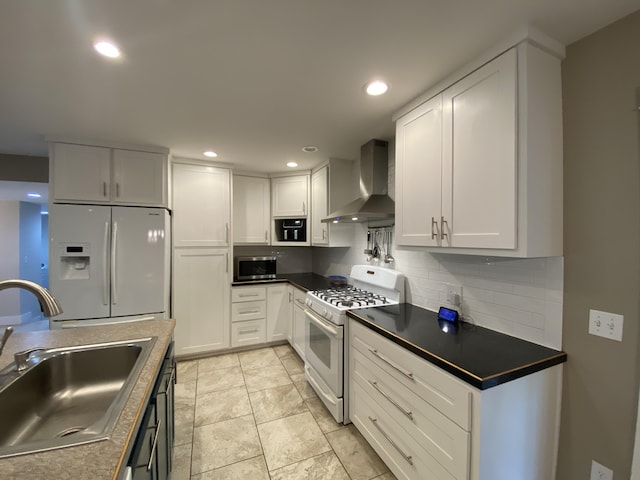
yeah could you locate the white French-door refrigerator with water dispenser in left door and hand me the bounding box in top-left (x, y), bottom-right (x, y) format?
top-left (49, 204), bottom-right (171, 329)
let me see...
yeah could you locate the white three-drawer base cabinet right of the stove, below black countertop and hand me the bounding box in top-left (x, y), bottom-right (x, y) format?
top-left (349, 320), bottom-right (562, 480)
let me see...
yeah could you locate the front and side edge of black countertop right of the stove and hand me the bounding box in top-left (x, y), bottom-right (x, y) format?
top-left (347, 310), bottom-right (567, 390)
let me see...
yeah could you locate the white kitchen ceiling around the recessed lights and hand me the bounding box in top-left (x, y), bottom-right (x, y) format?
top-left (0, 0), bottom-right (640, 171)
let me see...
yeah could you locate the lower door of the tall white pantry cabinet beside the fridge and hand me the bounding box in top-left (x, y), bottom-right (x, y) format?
top-left (173, 248), bottom-right (230, 355)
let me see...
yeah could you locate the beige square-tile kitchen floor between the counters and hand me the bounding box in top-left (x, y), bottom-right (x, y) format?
top-left (171, 345), bottom-right (395, 480)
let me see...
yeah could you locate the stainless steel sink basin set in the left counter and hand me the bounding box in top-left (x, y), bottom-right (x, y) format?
top-left (0, 337), bottom-right (155, 458)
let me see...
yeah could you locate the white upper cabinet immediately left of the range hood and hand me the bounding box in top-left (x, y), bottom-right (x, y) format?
top-left (311, 158), bottom-right (355, 247)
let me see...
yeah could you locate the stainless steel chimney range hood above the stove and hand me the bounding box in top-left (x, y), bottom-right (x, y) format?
top-left (321, 139), bottom-right (396, 223)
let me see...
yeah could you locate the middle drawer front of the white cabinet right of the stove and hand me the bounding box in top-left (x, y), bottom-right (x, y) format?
top-left (351, 350), bottom-right (471, 480)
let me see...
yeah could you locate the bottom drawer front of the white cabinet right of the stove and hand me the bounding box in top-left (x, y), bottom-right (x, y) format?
top-left (349, 382), bottom-right (456, 480)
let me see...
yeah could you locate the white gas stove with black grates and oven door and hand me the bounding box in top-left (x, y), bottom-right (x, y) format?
top-left (305, 265), bottom-right (404, 423)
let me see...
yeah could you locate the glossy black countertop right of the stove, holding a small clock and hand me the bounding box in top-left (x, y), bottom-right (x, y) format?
top-left (347, 303), bottom-right (567, 390)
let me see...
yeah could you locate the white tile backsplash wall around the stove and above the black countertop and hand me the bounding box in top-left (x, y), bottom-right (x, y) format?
top-left (313, 139), bottom-right (564, 349)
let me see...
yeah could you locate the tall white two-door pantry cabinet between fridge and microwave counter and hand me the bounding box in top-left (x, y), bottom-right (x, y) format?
top-left (172, 162), bottom-right (232, 355)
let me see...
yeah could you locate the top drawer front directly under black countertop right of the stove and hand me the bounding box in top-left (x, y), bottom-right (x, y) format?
top-left (349, 320), bottom-right (472, 431)
